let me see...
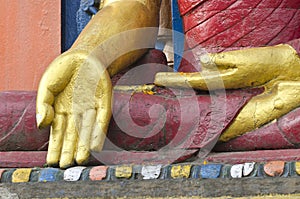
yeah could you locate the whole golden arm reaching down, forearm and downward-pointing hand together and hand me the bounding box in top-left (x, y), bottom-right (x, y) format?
top-left (37, 0), bottom-right (160, 168)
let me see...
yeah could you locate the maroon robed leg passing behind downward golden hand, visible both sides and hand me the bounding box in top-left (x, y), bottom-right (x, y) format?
top-left (0, 89), bottom-right (260, 151)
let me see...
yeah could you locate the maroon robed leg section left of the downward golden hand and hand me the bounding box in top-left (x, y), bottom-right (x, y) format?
top-left (0, 91), bottom-right (49, 151)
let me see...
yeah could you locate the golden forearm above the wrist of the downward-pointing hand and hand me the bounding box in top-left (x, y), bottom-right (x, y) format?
top-left (70, 0), bottom-right (160, 76)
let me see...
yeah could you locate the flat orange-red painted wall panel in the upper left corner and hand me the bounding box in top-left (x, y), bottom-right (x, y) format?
top-left (0, 0), bottom-right (61, 91)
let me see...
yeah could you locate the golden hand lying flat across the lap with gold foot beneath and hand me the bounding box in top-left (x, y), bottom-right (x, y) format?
top-left (155, 45), bottom-right (300, 141)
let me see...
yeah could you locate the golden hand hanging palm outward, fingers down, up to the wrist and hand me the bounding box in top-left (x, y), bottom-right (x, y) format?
top-left (37, 51), bottom-right (112, 168)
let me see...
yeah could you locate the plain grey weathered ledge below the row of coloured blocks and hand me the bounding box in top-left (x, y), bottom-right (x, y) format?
top-left (0, 178), bottom-right (300, 199)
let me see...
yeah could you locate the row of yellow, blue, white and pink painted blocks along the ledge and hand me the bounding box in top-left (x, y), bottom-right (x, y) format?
top-left (0, 161), bottom-right (300, 183)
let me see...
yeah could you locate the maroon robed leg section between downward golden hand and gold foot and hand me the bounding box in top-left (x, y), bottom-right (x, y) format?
top-left (105, 89), bottom-right (261, 151)
